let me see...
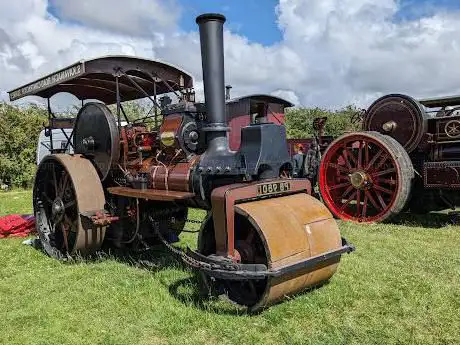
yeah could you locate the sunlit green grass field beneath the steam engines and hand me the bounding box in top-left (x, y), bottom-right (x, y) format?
top-left (0, 192), bottom-right (460, 345)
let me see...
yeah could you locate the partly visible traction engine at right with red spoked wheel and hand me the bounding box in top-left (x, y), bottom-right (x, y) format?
top-left (320, 94), bottom-right (460, 222)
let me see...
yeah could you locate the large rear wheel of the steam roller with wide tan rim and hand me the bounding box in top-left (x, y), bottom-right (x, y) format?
top-left (33, 154), bottom-right (106, 259)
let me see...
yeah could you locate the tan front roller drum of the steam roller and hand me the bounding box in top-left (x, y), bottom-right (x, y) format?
top-left (199, 193), bottom-right (342, 312)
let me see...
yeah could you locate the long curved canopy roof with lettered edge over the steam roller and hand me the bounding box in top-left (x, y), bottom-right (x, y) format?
top-left (8, 56), bottom-right (193, 104)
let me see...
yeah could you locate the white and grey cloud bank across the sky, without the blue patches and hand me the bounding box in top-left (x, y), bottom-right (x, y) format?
top-left (0, 0), bottom-right (460, 107)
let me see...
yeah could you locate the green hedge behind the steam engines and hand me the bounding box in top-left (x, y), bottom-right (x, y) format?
top-left (0, 102), bottom-right (359, 188)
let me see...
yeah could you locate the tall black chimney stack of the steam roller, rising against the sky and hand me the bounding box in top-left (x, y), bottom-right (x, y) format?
top-left (196, 13), bottom-right (231, 159)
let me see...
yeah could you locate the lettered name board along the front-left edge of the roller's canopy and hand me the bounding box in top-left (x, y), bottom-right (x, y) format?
top-left (9, 63), bottom-right (85, 101)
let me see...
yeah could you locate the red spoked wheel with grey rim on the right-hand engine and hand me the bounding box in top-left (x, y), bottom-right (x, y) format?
top-left (319, 132), bottom-right (414, 223)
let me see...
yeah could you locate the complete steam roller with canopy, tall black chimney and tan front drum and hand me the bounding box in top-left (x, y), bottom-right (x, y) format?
top-left (10, 14), bottom-right (353, 310)
